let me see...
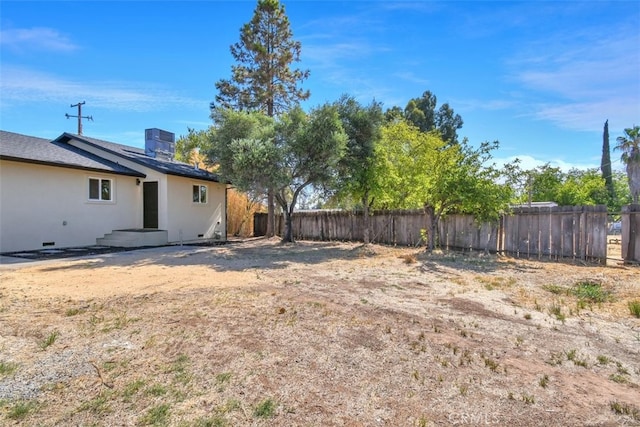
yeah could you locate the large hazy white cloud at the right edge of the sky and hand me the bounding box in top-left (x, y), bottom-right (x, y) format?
top-left (510, 25), bottom-right (640, 131)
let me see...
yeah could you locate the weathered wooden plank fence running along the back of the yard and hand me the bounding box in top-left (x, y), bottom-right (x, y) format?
top-left (254, 205), bottom-right (640, 263)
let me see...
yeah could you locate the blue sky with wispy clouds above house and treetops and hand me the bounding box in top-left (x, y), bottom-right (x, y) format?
top-left (0, 0), bottom-right (640, 170)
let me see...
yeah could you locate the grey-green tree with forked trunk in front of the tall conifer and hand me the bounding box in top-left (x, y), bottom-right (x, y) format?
top-left (210, 105), bottom-right (347, 242)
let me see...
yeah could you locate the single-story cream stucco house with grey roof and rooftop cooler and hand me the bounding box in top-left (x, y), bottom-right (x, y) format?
top-left (0, 129), bottom-right (228, 253)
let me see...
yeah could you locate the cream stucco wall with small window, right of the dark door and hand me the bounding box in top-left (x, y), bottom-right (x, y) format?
top-left (167, 176), bottom-right (226, 242)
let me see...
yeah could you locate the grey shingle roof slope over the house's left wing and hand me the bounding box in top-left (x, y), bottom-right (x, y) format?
top-left (0, 131), bottom-right (146, 178)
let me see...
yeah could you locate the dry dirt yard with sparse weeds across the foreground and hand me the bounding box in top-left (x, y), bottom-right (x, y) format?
top-left (0, 239), bottom-right (640, 426)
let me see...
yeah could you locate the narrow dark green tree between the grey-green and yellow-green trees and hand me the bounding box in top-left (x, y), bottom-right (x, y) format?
top-left (336, 95), bottom-right (384, 245)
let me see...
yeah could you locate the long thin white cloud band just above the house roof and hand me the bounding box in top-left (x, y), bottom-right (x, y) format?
top-left (0, 66), bottom-right (208, 112)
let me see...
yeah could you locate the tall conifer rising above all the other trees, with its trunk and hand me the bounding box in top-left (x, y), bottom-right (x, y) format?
top-left (211, 0), bottom-right (310, 236)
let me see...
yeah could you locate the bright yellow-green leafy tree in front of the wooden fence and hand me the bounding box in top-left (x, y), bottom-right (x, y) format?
top-left (375, 121), bottom-right (513, 249)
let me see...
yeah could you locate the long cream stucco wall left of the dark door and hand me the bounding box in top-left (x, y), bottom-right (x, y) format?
top-left (0, 160), bottom-right (142, 252)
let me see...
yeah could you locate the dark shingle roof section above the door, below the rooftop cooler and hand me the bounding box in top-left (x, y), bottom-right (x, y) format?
top-left (54, 132), bottom-right (225, 182)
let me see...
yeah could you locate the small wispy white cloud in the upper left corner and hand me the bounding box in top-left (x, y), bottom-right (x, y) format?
top-left (0, 27), bottom-right (79, 52)
